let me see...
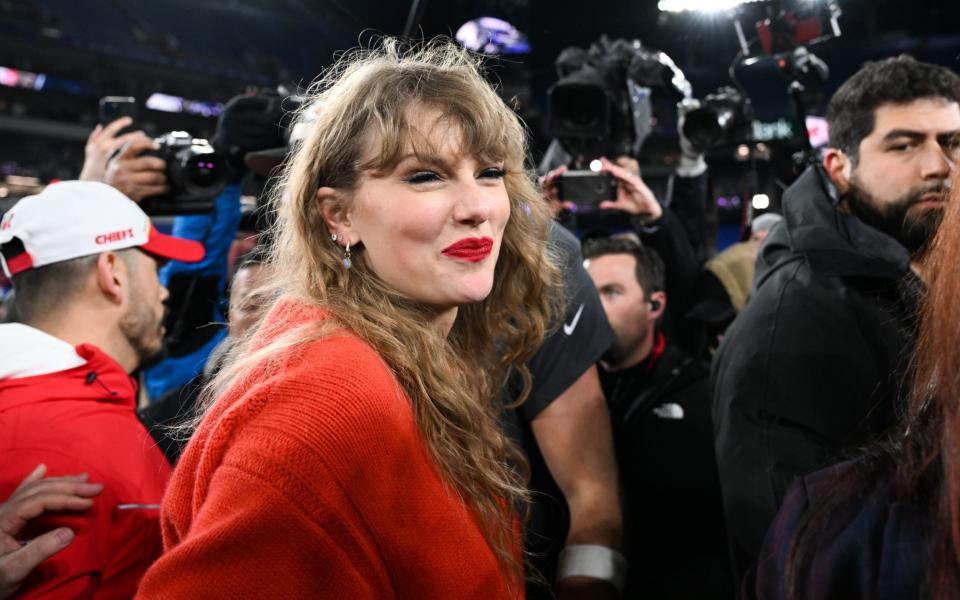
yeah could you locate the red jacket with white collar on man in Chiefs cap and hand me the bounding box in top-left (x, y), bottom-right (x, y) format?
top-left (0, 325), bottom-right (170, 598)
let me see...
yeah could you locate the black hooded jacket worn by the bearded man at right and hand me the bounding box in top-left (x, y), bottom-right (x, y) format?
top-left (712, 167), bottom-right (920, 578)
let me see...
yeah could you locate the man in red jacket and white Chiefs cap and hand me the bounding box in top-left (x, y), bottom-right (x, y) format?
top-left (0, 182), bottom-right (203, 598)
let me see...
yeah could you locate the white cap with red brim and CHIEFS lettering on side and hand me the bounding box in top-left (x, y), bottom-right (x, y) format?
top-left (0, 181), bottom-right (204, 277)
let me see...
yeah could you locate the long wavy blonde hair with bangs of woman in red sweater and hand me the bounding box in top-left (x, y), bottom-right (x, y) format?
top-left (201, 38), bottom-right (562, 582)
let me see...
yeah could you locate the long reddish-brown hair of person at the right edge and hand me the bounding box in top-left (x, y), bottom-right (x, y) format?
top-left (785, 171), bottom-right (960, 600)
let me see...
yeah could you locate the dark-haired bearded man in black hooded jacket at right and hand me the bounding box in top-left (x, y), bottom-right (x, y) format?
top-left (711, 56), bottom-right (960, 581)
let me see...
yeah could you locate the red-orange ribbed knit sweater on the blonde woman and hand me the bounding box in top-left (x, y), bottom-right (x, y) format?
top-left (138, 300), bottom-right (507, 599)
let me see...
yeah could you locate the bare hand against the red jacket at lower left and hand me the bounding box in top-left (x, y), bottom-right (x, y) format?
top-left (0, 465), bottom-right (103, 600)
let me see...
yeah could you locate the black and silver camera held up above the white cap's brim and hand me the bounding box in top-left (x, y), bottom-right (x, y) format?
top-left (140, 131), bottom-right (227, 215)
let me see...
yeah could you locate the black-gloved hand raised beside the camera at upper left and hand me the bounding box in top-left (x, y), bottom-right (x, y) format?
top-left (210, 95), bottom-right (284, 173)
